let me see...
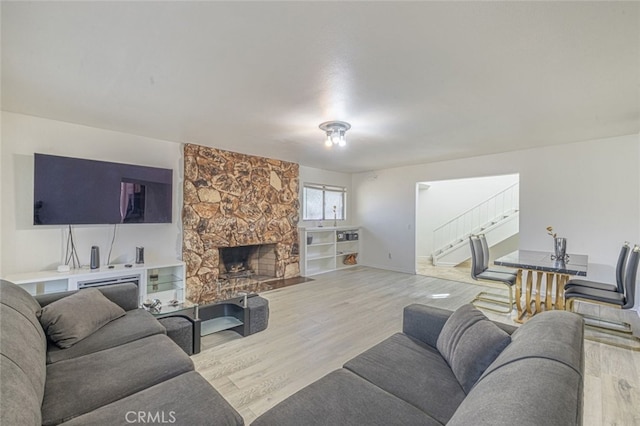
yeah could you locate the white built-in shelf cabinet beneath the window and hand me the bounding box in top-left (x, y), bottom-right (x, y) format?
top-left (300, 226), bottom-right (360, 276)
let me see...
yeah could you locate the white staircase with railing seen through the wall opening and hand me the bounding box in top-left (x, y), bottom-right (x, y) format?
top-left (431, 183), bottom-right (520, 266)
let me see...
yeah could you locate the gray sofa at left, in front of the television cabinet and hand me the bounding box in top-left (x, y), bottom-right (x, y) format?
top-left (0, 281), bottom-right (243, 425)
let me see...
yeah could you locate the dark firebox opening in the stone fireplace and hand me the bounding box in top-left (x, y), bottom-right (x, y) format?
top-left (219, 244), bottom-right (276, 281)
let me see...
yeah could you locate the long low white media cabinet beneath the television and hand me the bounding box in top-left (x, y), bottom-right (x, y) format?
top-left (4, 260), bottom-right (185, 306)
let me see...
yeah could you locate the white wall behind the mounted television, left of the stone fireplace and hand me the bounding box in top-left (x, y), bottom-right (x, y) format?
top-left (0, 111), bottom-right (182, 276)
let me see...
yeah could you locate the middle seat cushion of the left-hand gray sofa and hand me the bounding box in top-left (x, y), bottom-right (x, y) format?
top-left (42, 335), bottom-right (193, 425)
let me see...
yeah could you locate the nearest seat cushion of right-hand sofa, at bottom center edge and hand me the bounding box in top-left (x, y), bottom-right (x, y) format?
top-left (252, 369), bottom-right (441, 426)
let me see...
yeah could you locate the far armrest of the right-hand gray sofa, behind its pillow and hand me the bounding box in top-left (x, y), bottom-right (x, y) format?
top-left (402, 304), bottom-right (453, 348)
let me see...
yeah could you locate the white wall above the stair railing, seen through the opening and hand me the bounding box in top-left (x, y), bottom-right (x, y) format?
top-left (416, 175), bottom-right (519, 258)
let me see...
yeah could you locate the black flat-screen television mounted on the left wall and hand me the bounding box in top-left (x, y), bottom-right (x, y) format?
top-left (33, 153), bottom-right (173, 225)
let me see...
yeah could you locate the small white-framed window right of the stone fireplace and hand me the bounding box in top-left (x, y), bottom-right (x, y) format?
top-left (302, 183), bottom-right (347, 220)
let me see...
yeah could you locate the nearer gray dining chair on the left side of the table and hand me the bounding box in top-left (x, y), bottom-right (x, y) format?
top-left (469, 235), bottom-right (517, 314)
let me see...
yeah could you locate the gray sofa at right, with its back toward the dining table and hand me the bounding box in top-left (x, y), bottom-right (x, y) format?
top-left (252, 305), bottom-right (584, 426)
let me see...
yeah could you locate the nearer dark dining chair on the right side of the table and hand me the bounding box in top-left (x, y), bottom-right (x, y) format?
top-left (564, 245), bottom-right (640, 340)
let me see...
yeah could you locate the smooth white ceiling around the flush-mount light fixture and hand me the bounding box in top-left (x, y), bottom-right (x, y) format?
top-left (1, 1), bottom-right (640, 172)
